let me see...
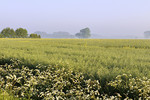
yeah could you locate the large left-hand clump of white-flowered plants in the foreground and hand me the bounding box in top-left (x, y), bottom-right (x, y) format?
top-left (0, 60), bottom-right (101, 100)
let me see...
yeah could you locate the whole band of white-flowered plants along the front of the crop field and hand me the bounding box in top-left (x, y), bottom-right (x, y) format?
top-left (0, 60), bottom-right (150, 100)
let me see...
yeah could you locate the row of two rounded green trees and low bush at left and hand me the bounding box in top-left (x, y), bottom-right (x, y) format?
top-left (0, 27), bottom-right (41, 38)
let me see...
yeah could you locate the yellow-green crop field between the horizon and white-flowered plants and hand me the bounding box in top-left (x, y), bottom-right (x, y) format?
top-left (0, 39), bottom-right (150, 99)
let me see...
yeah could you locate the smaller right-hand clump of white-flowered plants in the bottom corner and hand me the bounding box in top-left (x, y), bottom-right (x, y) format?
top-left (108, 74), bottom-right (150, 100)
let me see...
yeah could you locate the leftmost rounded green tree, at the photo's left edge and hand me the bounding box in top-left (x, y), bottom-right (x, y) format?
top-left (1, 27), bottom-right (16, 38)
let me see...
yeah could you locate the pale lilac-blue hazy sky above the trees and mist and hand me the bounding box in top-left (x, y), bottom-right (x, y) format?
top-left (0, 0), bottom-right (150, 35)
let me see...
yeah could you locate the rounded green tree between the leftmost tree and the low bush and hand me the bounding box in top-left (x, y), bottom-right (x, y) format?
top-left (15, 28), bottom-right (28, 38)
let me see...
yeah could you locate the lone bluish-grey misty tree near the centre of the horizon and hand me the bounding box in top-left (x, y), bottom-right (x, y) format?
top-left (75, 28), bottom-right (91, 38)
